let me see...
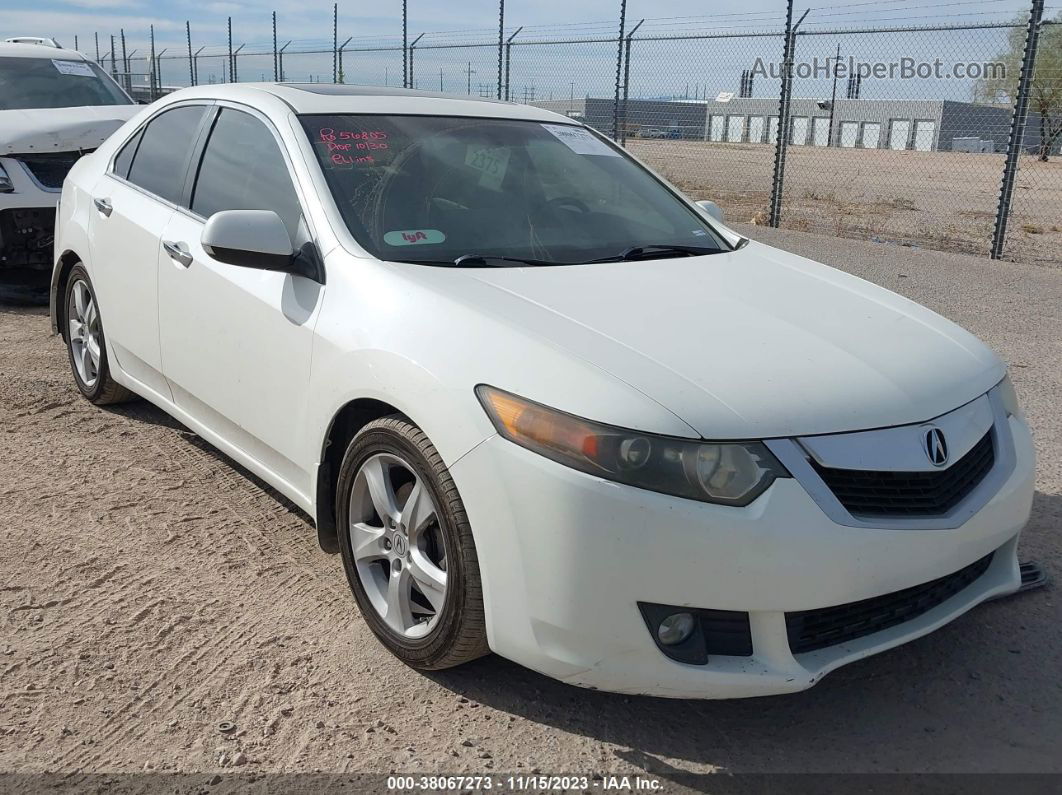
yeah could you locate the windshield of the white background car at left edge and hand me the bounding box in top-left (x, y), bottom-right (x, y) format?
top-left (0, 56), bottom-right (133, 110)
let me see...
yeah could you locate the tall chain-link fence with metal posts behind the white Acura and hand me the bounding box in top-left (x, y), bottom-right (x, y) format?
top-left (76, 0), bottom-right (1062, 262)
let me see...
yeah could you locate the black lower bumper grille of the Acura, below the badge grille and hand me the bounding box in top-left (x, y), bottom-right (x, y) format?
top-left (786, 553), bottom-right (994, 654)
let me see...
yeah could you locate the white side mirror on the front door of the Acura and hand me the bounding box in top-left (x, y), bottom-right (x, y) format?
top-left (200, 210), bottom-right (295, 273)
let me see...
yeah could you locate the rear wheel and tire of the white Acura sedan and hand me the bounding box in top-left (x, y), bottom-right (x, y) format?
top-left (64, 263), bottom-right (136, 405)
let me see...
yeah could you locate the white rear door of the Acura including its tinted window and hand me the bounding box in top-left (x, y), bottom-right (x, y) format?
top-left (88, 104), bottom-right (206, 397)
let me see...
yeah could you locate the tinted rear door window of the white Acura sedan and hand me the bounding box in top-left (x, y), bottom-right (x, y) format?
top-left (125, 105), bottom-right (206, 204)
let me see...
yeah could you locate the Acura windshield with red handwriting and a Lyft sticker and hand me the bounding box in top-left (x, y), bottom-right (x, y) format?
top-left (302, 115), bottom-right (725, 265)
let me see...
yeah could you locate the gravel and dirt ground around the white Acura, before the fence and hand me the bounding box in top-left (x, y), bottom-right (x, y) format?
top-left (0, 227), bottom-right (1062, 789)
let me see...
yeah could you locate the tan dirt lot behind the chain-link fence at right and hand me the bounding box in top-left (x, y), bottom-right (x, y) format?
top-left (628, 139), bottom-right (1062, 263)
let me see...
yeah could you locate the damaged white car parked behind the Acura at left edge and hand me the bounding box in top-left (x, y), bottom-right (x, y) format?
top-left (0, 36), bottom-right (137, 303)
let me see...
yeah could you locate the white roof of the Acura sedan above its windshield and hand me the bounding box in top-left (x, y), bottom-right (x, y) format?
top-left (168, 83), bottom-right (572, 124)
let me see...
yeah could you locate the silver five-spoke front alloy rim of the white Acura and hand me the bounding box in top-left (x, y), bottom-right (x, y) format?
top-left (349, 453), bottom-right (447, 640)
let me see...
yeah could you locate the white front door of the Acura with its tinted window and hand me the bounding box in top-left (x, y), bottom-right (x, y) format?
top-left (159, 103), bottom-right (324, 495)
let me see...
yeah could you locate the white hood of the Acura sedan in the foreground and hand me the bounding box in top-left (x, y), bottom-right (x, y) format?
top-left (409, 243), bottom-right (1006, 439)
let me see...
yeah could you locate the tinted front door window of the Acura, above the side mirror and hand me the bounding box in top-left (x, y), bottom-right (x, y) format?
top-left (191, 108), bottom-right (302, 240)
